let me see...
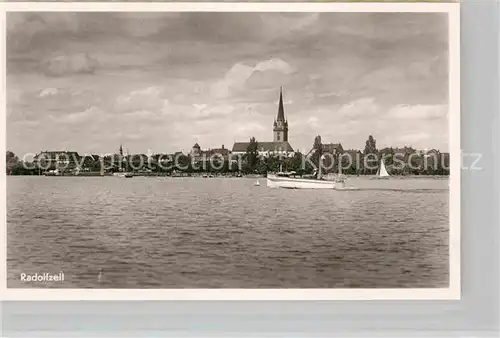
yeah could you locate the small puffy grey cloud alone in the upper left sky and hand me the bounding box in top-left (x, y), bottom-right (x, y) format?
top-left (42, 53), bottom-right (99, 76)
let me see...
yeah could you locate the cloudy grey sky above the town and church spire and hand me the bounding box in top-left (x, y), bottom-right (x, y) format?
top-left (6, 12), bottom-right (449, 156)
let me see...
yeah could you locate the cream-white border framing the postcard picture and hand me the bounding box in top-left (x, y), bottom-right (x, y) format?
top-left (0, 2), bottom-right (461, 301)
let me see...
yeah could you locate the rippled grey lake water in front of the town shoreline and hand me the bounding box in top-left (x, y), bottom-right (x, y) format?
top-left (7, 176), bottom-right (449, 288)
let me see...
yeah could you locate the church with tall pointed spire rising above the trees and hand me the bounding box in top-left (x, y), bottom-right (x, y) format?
top-left (232, 88), bottom-right (294, 157)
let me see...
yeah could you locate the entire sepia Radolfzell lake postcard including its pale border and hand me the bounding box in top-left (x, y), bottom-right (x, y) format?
top-left (2, 3), bottom-right (461, 299)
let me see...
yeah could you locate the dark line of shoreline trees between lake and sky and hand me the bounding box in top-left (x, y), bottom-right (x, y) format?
top-left (6, 135), bottom-right (449, 175)
